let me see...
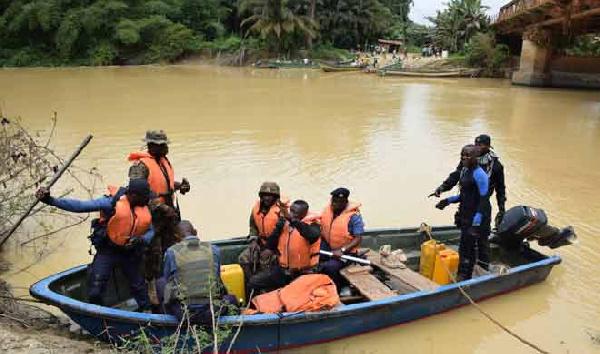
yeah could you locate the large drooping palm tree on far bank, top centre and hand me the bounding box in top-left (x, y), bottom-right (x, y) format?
top-left (240, 0), bottom-right (318, 53)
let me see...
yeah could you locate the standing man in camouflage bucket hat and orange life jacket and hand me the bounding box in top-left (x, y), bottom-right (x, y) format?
top-left (129, 130), bottom-right (190, 305)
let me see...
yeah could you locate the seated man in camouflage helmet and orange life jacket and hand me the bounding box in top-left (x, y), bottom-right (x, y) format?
top-left (238, 182), bottom-right (288, 282)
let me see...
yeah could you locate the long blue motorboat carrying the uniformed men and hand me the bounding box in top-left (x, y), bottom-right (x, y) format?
top-left (30, 227), bottom-right (561, 353)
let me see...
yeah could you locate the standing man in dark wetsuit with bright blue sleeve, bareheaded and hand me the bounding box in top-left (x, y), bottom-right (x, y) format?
top-left (435, 145), bottom-right (491, 281)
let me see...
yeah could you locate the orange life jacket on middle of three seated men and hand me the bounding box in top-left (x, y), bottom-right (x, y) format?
top-left (277, 213), bottom-right (321, 270)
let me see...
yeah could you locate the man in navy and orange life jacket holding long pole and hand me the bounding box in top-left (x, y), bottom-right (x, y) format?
top-left (36, 178), bottom-right (154, 311)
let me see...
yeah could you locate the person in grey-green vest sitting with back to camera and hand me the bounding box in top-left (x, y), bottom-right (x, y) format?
top-left (157, 220), bottom-right (236, 324)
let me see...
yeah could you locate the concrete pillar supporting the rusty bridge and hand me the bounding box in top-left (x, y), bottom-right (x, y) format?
top-left (512, 28), bottom-right (552, 86)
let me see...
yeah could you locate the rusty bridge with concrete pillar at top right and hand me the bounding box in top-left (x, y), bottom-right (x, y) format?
top-left (492, 0), bottom-right (600, 88)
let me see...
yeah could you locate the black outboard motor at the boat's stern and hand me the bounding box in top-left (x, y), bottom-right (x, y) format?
top-left (495, 205), bottom-right (577, 249)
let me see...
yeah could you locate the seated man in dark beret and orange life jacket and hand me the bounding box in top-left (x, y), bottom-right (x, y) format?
top-left (320, 188), bottom-right (364, 290)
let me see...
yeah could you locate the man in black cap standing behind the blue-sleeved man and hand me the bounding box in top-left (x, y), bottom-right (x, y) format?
top-left (433, 134), bottom-right (506, 227)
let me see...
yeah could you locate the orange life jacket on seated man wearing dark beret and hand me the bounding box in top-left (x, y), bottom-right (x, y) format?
top-left (321, 203), bottom-right (360, 253)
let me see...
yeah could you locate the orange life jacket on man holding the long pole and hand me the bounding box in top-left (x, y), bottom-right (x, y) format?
top-left (100, 186), bottom-right (152, 246)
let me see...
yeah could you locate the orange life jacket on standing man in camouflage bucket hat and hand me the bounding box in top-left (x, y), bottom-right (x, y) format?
top-left (129, 152), bottom-right (175, 204)
